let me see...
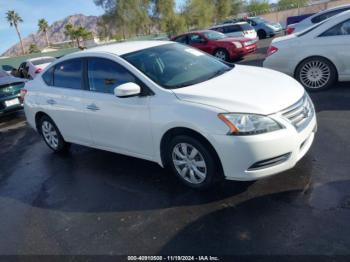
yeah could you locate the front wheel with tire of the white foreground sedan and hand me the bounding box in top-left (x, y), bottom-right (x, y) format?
top-left (165, 135), bottom-right (219, 189)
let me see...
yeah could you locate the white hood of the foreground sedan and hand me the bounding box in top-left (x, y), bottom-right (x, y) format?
top-left (173, 65), bottom-right (305, 115)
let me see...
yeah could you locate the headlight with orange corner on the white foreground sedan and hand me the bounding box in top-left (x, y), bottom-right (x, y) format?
top-left (218, 113), bottom-right (283, 135)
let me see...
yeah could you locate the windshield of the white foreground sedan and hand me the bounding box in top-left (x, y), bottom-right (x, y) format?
top-left (122, 43), bottom-right (231, 89)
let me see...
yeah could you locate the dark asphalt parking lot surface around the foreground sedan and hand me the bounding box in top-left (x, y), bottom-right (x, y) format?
top-left (0, 39), bottom-right (350, 255)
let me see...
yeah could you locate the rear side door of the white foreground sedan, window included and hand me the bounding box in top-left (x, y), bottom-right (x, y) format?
top-left (41, 58), bottom-right (92, 145)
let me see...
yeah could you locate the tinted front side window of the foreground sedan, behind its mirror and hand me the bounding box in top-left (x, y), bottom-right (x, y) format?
top-left (88, 58), bottom-right (136, 94)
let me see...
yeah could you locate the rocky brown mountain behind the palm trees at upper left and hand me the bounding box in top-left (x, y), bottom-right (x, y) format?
top-left (2, 14), bottom-right (99, 56)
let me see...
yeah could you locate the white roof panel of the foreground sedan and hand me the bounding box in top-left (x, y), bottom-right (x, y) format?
top-left (80, 40), bottom-right (174, 56)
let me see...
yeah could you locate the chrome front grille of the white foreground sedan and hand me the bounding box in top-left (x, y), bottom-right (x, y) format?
top-left (282, 95), bottom-right (315, 131)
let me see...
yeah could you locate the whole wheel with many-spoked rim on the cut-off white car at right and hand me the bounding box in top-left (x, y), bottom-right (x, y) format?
top-left (295, 57), bottom-right (337, 92)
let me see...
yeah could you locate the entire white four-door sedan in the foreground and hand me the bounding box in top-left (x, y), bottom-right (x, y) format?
top-left (24, 41), bottom-right (316, 188)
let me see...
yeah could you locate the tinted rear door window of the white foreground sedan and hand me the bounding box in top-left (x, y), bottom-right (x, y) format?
top-left (53, 59), bottom-right (82, 89)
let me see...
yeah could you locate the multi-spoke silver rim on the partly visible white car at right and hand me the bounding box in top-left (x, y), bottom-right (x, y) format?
top-left (300, 61), bottom-right (331, 89)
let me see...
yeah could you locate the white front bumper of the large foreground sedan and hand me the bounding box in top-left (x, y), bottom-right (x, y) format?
top-left (213, 114), bottom-right (317, 181)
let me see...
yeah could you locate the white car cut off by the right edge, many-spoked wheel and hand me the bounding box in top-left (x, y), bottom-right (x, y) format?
top-left (264, 11), bottom-right (350, 91)
